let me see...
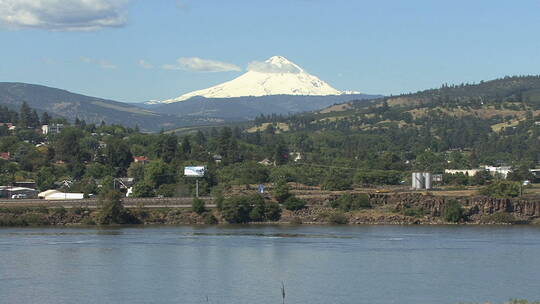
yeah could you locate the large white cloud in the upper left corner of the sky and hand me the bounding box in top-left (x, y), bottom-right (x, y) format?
top-left (0, 0), bottom-right (129, 31)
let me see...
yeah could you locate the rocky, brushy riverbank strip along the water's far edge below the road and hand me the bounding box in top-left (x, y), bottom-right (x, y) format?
top-left (0, 205), bottom-right (540, 227)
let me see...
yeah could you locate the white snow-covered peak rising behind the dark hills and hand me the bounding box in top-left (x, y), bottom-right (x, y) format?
top-left (152, 56), bottom-right (359, 104)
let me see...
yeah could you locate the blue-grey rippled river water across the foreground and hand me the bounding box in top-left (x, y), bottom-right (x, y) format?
top-left (0, 225), bottom-right (540, 304)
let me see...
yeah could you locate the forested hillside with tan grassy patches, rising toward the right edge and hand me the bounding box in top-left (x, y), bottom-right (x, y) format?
top-left (248, 76), bottom-right (540, 170)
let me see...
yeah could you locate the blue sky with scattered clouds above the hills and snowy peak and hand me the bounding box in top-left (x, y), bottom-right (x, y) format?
top-left (0, 0), bottom-right (540, 102)
